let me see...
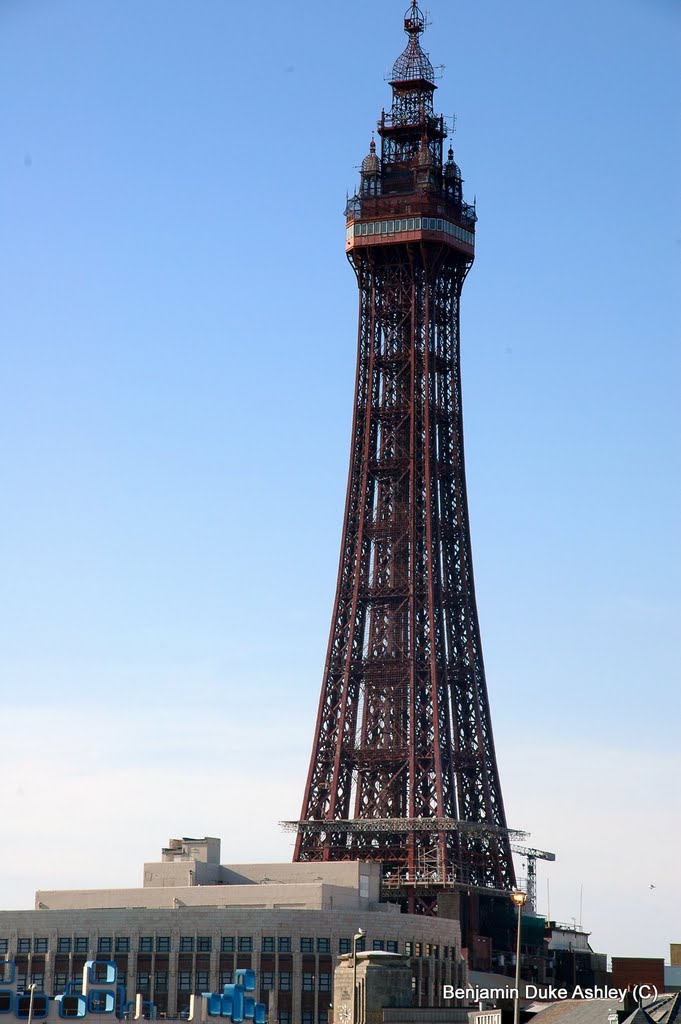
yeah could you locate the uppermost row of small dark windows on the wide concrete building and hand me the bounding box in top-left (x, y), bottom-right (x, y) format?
top-left (0, 935), bottom-right (455, 959)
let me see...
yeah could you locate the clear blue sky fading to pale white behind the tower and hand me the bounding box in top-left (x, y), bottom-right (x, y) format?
top-left (0, 0), bottom-right (681, 955)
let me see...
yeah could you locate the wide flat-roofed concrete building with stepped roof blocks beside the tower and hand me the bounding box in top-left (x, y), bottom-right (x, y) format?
top-left (0, 839), bottom-right (464, 1024)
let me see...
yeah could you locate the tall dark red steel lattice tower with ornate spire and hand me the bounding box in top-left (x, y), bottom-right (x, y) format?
top-left (294, 0), bottom-right (515, 912)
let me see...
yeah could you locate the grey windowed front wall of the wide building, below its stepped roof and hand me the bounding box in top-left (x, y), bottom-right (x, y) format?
top-left (0, 905), bottom-right (464, 1024)
